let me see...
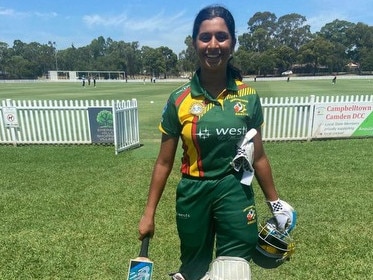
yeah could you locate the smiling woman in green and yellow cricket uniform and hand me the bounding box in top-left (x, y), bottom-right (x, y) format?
top-left (139, 6), bottom-right (294, 280)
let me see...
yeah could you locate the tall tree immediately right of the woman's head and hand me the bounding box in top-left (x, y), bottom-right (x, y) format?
top-left (237, 12), bottom-right (306, 75)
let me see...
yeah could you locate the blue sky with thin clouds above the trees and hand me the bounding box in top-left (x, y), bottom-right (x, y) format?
top-left (0, 0), bottom-right (373, 54)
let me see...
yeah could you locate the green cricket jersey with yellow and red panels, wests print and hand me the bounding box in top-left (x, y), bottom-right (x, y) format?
top-left (159, 69), bottom-right (263, 178)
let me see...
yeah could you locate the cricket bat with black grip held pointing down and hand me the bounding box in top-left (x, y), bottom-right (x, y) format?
top-left (127, 236), bottom-right (153, 280)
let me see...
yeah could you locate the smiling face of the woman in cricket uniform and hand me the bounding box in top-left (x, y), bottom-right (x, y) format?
top-left (194, 17), bottom-right (234, 71)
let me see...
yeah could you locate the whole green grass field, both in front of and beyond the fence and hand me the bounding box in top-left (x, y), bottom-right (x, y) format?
top-left (0, 79), bottom-right (373, 280)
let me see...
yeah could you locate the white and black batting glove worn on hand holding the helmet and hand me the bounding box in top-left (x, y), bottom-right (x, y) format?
top-left (267, 199), bottom-right (297, 233)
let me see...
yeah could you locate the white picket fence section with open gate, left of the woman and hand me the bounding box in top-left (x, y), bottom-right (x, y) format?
top-left (0, 99), bottom-right (140, 154)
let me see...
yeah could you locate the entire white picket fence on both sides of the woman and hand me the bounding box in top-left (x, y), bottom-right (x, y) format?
top-left (0, 95), bottom-right (373, 154)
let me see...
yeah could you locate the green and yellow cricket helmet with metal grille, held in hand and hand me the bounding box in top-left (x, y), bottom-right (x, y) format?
top-left (256, 218), bottom-right (295, 262)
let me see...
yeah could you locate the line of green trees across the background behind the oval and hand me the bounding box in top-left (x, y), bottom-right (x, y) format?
top-left (0, 12), bottom-right (373, 79)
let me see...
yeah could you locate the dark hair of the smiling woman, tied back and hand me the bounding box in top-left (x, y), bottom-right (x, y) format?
top-left (192, 5), bottom-right (242, 81)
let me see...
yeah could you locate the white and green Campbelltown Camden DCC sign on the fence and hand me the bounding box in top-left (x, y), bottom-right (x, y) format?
top-left (312, 102), bottom-right (373, 138)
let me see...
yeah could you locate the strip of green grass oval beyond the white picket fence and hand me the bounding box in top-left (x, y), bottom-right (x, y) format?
top-left (0, 76), bottom-right (373, 101)
